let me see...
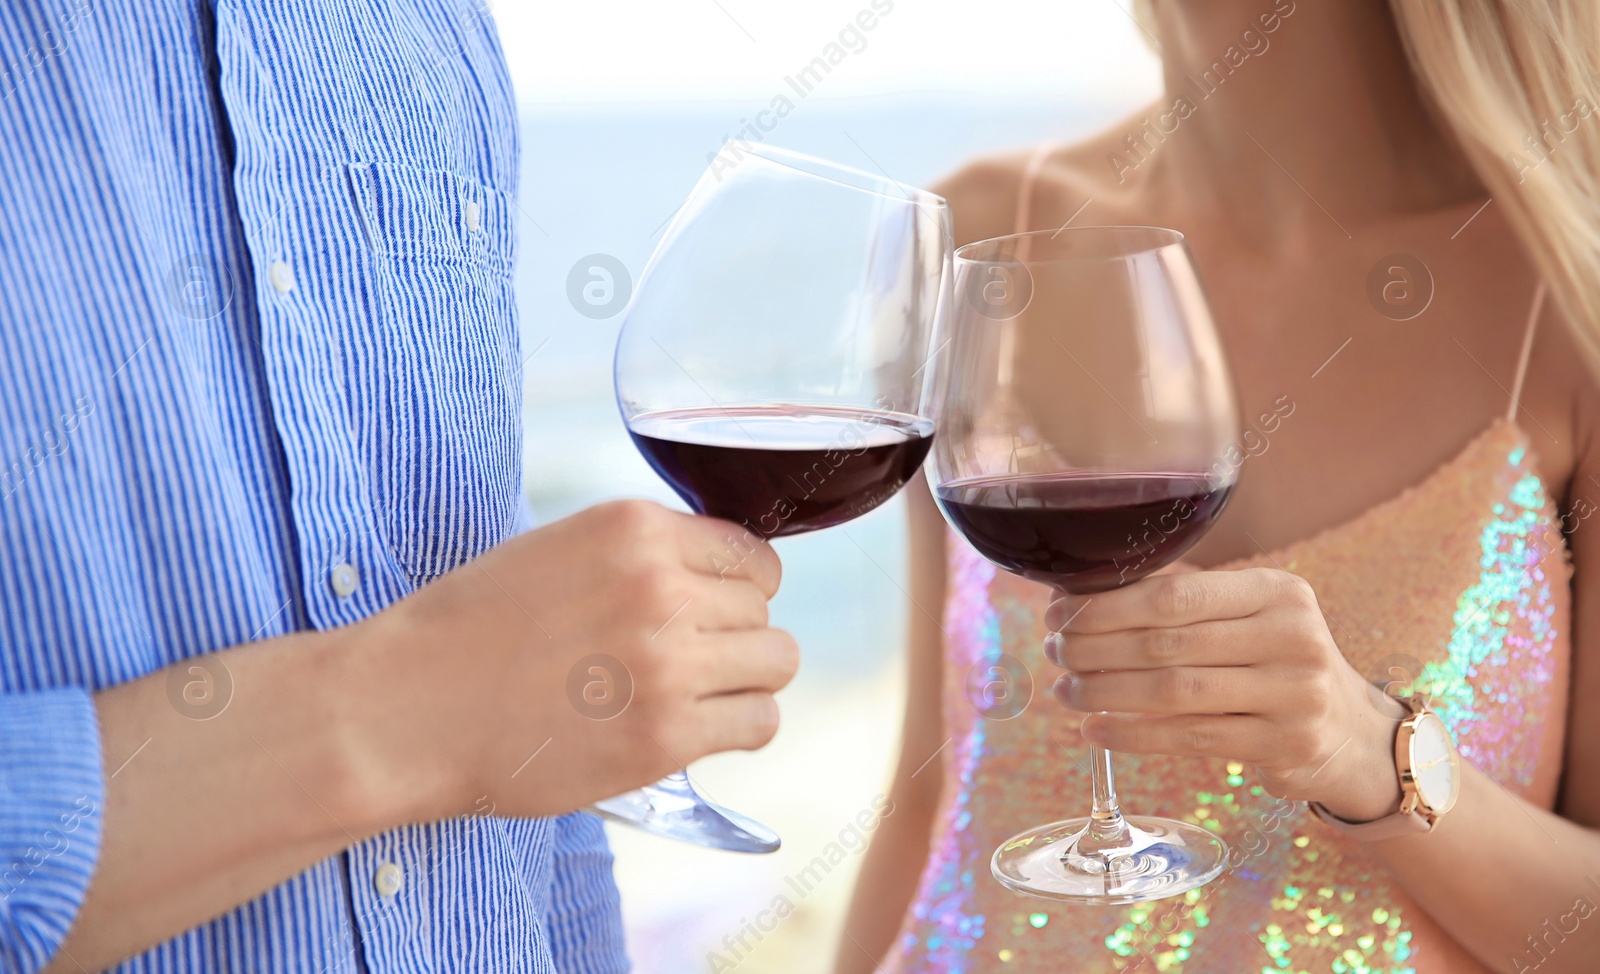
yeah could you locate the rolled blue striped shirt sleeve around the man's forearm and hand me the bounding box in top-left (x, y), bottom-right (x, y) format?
top-left (0, 688), bottom-right (106, 974)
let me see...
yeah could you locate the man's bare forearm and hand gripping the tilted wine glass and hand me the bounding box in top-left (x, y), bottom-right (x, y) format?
top-left (42, 502), bottom-right (800, 971)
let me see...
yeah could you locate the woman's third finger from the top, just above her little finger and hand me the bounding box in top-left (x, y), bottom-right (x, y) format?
top-left (1054, 667), bottom-right (1274, 715)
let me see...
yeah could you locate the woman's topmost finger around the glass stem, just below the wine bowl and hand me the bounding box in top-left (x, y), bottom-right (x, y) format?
top-left (1045, 568), bottom-right (1302, 633)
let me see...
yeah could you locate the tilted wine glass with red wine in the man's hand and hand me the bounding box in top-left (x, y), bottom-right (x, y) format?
top-left (595, 146), bottom-right (950, 852)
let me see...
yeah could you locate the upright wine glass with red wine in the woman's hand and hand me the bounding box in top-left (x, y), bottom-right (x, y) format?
top-left (928, 227), bottom-right (1238, 904)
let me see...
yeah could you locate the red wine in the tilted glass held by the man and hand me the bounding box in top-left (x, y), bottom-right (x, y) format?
top-left (627, 405), bottom-right (933, 537)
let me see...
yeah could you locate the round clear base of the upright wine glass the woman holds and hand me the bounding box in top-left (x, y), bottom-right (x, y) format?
top-left (990, 816), bottom-right (1227, 905)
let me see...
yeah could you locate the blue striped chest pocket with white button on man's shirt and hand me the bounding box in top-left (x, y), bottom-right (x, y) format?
top-left (346, 162), bottom-right (522, 584)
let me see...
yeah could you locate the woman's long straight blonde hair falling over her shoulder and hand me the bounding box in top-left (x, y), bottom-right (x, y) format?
top-left (1134, 0), bottom-right (1600, 356)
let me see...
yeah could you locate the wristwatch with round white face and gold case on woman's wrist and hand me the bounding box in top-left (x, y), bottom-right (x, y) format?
top-left (1310, 696), bottom-right (1461, 841)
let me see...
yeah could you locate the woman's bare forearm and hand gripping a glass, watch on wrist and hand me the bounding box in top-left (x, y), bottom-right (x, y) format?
top-left (1046, 412), bottom-right (1600, 974)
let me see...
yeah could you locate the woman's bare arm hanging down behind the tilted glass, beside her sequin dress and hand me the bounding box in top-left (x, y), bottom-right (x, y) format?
top-left (835, 473), bottom-right (946, 974)
